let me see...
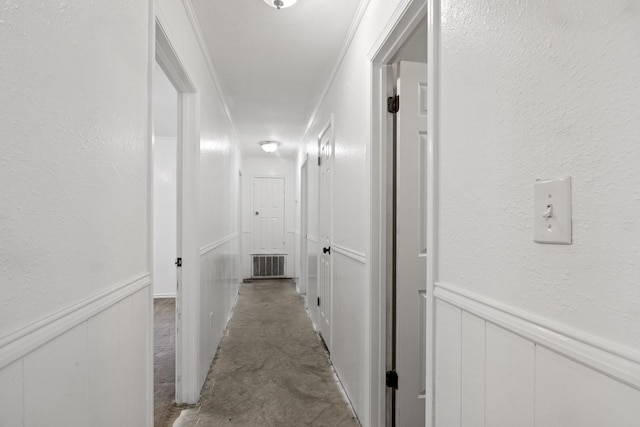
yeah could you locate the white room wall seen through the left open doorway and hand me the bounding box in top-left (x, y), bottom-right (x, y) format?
top-left (152, 63), bottom-right (178, 298)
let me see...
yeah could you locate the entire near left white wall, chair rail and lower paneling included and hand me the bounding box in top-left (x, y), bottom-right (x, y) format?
top-left (0, 0), bottom-right (152, 426)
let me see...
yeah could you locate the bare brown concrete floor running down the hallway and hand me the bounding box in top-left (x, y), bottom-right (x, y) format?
top-left (174, 280), bottom-right (359, 427)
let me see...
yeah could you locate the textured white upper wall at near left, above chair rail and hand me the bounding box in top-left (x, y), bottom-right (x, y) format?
top-left (0, 0), bottom-right (149, 333)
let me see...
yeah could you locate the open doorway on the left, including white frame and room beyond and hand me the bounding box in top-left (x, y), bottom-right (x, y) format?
top-left (149, 16), bottom-right (200, 424)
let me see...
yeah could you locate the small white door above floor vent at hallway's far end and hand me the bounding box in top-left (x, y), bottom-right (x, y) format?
top-left (252, 177), bottom-right (285, 254)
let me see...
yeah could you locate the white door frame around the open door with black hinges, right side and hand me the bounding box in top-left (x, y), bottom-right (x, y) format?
top-left (368, 0), bottom-right (440, 426)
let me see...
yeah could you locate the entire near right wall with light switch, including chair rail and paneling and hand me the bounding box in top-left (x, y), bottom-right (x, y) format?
top-left (434, 0), bottom-right (640, 426)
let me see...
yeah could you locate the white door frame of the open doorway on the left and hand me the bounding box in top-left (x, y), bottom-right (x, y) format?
top-left (154, 15), bottom-right (200, 404)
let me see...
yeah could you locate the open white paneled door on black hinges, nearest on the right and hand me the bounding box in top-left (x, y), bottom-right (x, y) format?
top-left (395, 61), bottom-right (427, 426)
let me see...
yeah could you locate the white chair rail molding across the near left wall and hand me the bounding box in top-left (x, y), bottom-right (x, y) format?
top-left (0, 273), bottom-right (151, 369)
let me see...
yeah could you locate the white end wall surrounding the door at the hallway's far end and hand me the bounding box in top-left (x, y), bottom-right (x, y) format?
top-left (242, 154), bottom-right (298, 278)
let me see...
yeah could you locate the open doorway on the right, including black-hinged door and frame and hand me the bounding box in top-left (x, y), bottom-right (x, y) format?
top-left (371, 1), bottom-right (430, 426)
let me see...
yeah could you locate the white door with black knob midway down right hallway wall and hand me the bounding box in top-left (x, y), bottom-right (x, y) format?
top-left (317, 124), bottom-right (333, 351)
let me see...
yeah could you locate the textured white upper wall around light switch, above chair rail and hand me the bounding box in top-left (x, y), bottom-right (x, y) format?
top-left (437, 0), bottom-right (640, 351)
